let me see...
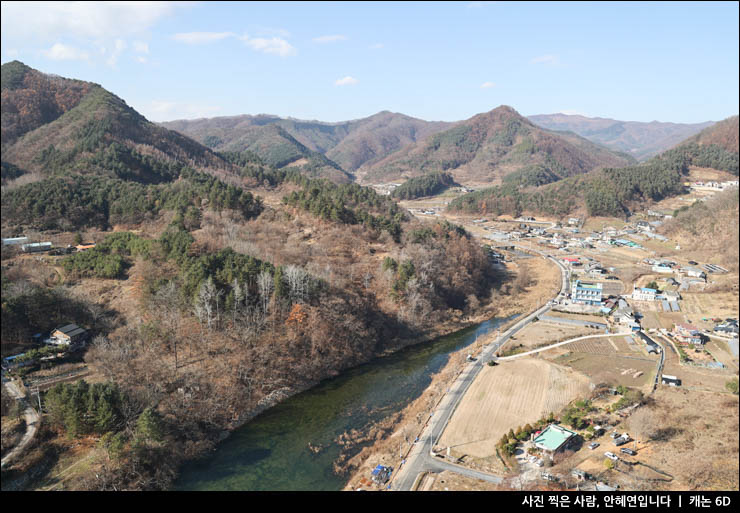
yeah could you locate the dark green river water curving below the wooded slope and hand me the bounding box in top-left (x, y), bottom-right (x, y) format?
top-left (175, 319), bottom-right (509, 490)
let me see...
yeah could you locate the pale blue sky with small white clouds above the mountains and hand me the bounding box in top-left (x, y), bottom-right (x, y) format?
top-left (0, 2), bottom-right (740, 123)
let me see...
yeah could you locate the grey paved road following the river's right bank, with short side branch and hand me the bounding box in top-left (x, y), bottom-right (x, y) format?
top-left (390, 246), bottom-right (570, 491)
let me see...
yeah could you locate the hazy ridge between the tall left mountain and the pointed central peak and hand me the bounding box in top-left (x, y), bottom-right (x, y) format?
top-left (162, 111), bottom-right (452, 176)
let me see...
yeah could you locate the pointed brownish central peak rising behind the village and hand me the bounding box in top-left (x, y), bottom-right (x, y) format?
top-left (357, 106), bottom-right (634, 184)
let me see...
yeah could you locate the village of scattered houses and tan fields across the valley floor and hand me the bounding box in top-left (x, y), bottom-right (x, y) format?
top-left (350, 182), bottom-right (738, 491)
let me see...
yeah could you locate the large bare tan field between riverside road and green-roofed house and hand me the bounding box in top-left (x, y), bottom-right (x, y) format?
top-left (439, 357), bottom-right (590, 458)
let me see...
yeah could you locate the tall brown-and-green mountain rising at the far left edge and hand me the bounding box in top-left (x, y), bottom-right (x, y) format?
top-left (2, 61), bottom-right (234, 183)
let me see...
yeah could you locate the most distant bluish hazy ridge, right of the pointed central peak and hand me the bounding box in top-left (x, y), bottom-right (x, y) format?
top-left (528, 113), bottom-right (712, 161)
